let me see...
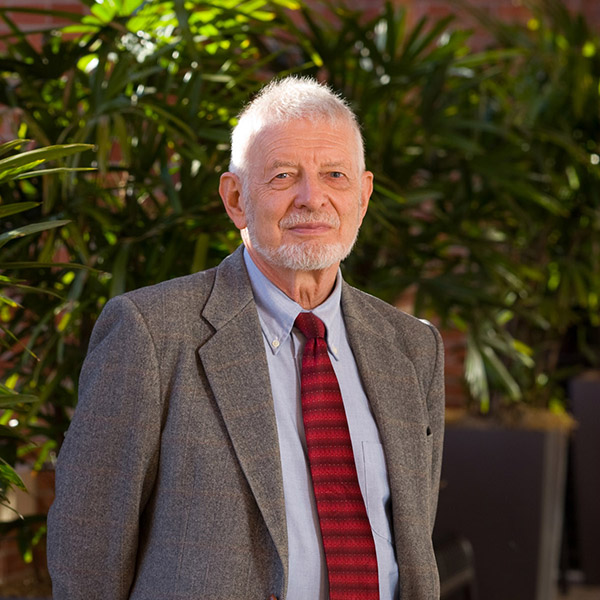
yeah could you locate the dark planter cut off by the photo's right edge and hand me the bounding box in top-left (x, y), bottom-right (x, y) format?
top-left (569, 372), bottom-right (600, 585)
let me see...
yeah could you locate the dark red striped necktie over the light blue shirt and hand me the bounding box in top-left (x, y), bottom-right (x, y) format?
top-left (294, 313), bottom-right (379, 600)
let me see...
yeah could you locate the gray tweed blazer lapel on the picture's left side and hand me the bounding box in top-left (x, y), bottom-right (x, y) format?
top-left (198, 249), bottom-right (288, 581)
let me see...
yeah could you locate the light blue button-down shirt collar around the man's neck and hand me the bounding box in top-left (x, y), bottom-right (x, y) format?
top-left (244, 248), bottom-right (343, 359)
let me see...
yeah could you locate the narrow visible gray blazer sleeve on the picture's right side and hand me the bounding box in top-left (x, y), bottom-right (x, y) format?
top-left (427, 325), bottom-right (445, 532)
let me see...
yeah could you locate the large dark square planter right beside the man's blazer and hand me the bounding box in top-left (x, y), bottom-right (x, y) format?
top-left (435, 425), bottom-right (568, 600)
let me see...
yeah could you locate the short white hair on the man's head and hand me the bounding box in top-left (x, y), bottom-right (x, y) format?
top-left (229, 76), bottom-right (365, 179)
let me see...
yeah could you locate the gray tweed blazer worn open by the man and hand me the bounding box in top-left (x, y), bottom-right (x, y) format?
top-left (48, 245), bottom-right (444, 600)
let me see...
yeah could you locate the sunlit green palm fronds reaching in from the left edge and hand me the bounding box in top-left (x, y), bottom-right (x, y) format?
top-left (0, 140), bottom-right (91, 572)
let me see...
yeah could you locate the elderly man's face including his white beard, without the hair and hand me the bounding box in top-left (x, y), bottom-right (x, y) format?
top-left (238, 119), bottom-right (372, 271)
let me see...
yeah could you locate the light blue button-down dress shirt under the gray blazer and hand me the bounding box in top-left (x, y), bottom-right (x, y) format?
top-left (244, 251), bottom-right (398, 600)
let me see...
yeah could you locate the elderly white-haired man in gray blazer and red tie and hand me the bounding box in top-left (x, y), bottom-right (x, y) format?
top-left (48, 78), bottom-right (444, 600)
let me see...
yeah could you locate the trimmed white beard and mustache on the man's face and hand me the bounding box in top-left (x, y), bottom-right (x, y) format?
top-left (241, 209), bottom-right (358, 271)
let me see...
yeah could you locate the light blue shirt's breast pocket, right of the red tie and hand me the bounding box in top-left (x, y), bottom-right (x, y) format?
top-left (362, 442), bottom-right (392, 543)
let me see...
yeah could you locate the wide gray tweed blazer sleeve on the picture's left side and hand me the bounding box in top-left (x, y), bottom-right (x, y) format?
top-left (48, 296), bottom-right (161, 600)
